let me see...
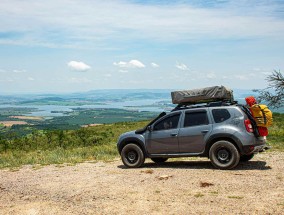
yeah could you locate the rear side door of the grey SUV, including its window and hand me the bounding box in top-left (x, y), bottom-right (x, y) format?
top-left (179, 109), bottom-right (212, 153)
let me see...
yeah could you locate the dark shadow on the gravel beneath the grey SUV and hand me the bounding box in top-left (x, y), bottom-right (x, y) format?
top-left (118, 160), bottom-right (271, 170)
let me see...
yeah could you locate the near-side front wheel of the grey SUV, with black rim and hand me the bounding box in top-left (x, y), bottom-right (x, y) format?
top-left (121, 143), bottom-right (145, 168)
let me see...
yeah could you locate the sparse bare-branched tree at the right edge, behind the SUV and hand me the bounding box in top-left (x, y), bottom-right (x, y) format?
top-left (256, 70), bottom-right (284, 108)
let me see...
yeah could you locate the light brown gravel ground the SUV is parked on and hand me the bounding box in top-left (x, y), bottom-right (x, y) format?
top-left (0, 152), bottom-right (284, 215)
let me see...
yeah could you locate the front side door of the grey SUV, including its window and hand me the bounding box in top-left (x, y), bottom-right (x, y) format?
top-left (145, 112), bottom-right (181, 154)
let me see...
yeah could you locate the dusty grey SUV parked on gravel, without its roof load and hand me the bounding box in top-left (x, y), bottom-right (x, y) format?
top-left (117, 104), bottom-right (267, 169)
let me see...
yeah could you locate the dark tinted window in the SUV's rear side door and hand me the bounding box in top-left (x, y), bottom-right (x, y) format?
top-left (184, 111), bottom-right (208, 127)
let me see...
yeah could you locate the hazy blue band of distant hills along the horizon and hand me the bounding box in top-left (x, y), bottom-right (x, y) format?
top-left (0, 89), bottom-right (284, 112)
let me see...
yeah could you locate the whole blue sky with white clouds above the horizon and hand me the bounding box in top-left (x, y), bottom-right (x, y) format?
top-left (0, 0), bottom-right (284, 94)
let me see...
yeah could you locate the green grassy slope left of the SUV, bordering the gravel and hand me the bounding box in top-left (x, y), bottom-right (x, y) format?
top-left (0, 121), bottom-right (143, 168)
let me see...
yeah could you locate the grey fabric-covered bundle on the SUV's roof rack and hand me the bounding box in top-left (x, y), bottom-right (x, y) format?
top-left (171, 86), bottom-right (234, 105)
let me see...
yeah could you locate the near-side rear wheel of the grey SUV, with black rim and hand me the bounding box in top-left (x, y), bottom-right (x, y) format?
top-left (209, 140), bottom-right (240, 169)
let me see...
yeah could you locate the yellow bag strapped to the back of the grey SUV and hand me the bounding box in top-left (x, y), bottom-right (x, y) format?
top-left (250, 104), bottom-right (273, 127)
